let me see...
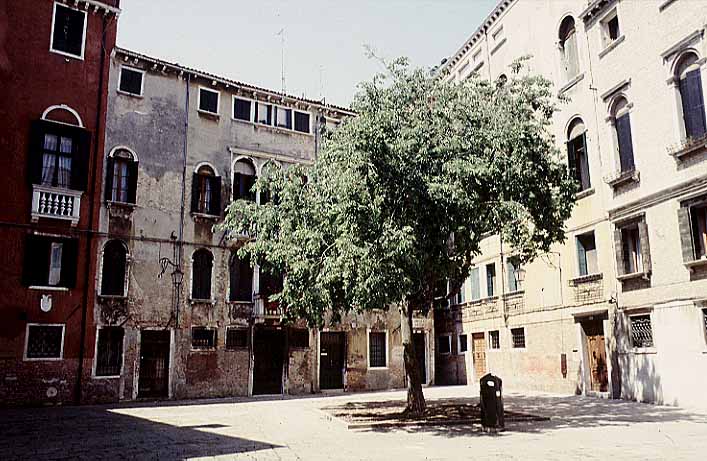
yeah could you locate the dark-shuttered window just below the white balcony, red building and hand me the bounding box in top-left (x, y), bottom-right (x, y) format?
top-left (22, 234), bottom-right (79, 288)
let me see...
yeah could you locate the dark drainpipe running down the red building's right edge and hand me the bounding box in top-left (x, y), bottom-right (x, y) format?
top-left (74, 16), bottom-right (108, 405)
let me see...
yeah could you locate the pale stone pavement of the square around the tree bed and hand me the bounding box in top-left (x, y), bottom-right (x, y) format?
top-left (0, 386), bottom-right (707, 461)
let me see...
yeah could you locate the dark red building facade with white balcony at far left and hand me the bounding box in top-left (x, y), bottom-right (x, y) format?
top-left (0, 0), bottom-right (120, 405)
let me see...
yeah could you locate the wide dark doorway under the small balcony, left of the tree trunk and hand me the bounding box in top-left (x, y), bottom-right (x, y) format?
top-left (253, 328), bottom-right (285, 395)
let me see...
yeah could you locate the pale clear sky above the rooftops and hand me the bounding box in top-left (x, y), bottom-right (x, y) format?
top-left (118, 0), bottom-right (498, 105)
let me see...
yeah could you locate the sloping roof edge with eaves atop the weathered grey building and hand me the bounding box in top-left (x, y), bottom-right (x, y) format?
top-left (115, 46), bottom-right (355, 115)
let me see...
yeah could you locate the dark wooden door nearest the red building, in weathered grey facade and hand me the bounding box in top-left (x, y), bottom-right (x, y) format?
top-left (138, 330), bottom-right (170, 397)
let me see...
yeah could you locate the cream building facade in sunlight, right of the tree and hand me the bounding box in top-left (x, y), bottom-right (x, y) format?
top-left (436, 0), bottom-right (707, 406)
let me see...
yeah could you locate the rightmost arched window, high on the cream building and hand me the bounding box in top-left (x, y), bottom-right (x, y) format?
top-left (675, 53), bottom-right (707, 139)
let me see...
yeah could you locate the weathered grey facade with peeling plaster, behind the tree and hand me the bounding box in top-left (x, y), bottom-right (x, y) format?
top-left (90, 45), bottom-right (433, 401)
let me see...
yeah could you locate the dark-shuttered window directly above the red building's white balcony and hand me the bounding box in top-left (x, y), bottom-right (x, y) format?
top-left (29, 120), bottom-right (90, 190)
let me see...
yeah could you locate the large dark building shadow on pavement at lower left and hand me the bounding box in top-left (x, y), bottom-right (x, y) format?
top-left (0, 406), bottom-right (280, 460)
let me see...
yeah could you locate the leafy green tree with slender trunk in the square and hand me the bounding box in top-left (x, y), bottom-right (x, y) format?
top-left (222, 59), bottom-right (575, 415)
